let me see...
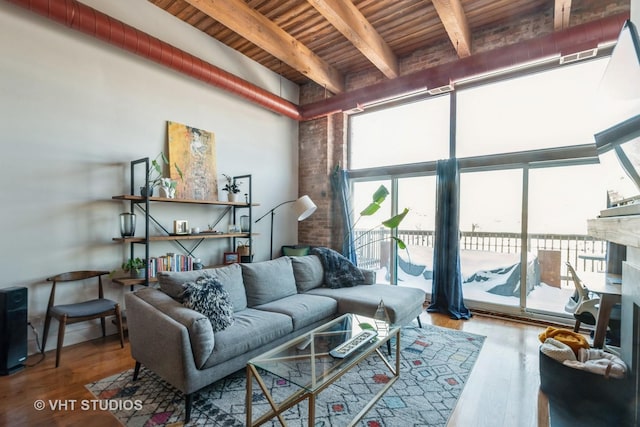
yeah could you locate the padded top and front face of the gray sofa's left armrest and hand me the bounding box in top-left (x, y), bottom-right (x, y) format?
top-left (134, 288), bottom-right (215, 368)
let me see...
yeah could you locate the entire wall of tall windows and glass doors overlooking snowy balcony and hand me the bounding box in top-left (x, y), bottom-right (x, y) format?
top-left (349, 53), bottom-right (624, 322)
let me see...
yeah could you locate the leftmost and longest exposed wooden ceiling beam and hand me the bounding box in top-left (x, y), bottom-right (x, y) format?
top-left (185, 0), bottom-right (344, 93)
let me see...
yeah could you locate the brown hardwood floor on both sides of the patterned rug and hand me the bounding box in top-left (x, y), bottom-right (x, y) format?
top-left (0, 313), bottom-right (548, 427)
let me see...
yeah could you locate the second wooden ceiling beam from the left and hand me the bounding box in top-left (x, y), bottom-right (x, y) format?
top-left (307, 0), bottom-right (399, 79)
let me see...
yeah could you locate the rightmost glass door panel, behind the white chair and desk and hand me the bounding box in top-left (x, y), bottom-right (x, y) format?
top-left (527, 164), bottom-right (607, 315)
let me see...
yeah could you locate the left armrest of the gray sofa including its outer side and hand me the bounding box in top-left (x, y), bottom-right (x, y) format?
top-left (125, 288), bottom-right (215, 369)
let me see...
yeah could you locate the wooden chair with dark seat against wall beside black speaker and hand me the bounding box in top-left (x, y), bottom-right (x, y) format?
top-left (42, 271), bottom-right (124, 368)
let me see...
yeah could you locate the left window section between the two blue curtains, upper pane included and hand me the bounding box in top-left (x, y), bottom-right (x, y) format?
top-left (349, 95), bottom-right (450, 288)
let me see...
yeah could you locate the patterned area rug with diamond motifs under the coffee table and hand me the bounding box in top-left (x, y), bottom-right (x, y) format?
top-left (86, 325), bottom-right (485, 427)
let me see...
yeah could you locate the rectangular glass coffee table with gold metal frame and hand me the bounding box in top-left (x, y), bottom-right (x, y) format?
top-left (246, 314), bottom-right (400, 426)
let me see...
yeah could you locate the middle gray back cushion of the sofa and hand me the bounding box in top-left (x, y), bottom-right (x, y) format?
top-left (241, 257), bottom-right (297, 307)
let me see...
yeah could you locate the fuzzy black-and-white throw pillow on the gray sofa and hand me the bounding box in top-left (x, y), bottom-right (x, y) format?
top-left (182, 277), bottom-right (233, 332)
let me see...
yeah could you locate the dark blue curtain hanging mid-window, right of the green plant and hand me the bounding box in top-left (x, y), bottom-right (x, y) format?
top-left (427, 159), bottom-right (472, 319)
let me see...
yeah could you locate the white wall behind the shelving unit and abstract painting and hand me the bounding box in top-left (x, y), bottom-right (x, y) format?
top-left (0, 0), bottom-right (298, 353)
